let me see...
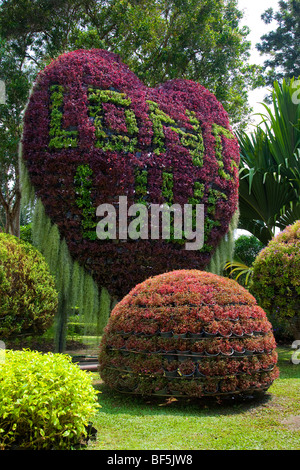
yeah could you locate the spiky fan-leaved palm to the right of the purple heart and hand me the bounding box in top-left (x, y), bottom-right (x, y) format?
top-left (238, 79), bottom-right (300, 245)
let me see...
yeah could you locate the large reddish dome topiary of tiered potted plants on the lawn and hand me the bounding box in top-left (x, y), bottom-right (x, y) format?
top-left (99, 270), bottom-right (278, 397)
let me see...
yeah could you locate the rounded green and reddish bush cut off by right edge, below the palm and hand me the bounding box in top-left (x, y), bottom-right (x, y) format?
top-left (251, 220), bottom-right (300, 333)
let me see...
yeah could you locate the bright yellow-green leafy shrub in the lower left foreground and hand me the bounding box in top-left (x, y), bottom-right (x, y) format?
top-left (0, 350), bottom-right (99, 450)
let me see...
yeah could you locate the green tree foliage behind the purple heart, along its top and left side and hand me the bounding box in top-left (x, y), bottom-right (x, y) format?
top-left (0, 0), bottom-right (259, 236)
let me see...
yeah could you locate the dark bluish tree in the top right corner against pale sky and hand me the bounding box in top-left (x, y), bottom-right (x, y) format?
top-left (256, 0), bottom-right (300, 85)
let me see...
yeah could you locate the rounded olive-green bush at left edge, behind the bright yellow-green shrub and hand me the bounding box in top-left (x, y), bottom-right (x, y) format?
top-left (0, 233), bottom-right (58, 339)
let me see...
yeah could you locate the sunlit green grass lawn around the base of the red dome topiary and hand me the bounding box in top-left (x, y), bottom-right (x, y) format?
top-left (89, 347), bottom-right (300, 450)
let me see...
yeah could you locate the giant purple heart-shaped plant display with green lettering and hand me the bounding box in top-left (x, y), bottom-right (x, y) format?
top-left (23, 50), bottom-right (239, 298)
